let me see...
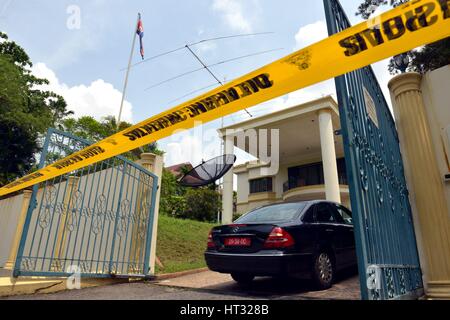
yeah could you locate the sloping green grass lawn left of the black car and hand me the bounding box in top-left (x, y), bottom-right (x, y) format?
top-left (156, 215), bottom-right (215, 274)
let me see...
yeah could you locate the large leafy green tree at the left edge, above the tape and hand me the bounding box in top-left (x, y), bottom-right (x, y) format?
top-left (0, 32), bottom-right (72, 186)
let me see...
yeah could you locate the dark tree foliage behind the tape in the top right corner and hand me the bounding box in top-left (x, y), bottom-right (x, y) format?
top-left (356, 0), bottom-right (450, 74)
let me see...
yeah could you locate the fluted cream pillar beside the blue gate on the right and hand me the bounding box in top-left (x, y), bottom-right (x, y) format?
top-left (389, 73), bottom-right (450, 299)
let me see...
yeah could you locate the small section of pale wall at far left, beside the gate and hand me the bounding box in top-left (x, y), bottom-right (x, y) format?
top-left (0, 194), bottom-right (23, 268)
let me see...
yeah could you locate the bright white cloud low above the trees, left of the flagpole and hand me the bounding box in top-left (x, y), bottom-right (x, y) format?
top-left (32, 63), bottom-right (132, 122)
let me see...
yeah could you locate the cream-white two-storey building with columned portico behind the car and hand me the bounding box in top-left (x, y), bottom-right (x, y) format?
top-left (219, 96), bottom-right (350, 223)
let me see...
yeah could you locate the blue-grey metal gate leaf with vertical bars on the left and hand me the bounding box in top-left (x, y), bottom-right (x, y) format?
top-left (14, 129), bottom-right (158, 277)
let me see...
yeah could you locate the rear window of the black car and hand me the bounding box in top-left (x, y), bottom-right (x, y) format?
top-left (235, 202), bottom-right (306, 223)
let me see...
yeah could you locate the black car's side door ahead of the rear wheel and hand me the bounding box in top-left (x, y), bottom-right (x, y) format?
top-left (330, 204), bottom-right (356, 267)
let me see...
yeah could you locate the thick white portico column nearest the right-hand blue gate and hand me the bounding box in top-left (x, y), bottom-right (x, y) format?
top-left (319, 109), bottom-right (341, 203)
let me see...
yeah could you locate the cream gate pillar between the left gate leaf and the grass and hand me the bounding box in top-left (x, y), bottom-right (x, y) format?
top-left (140, 153), bottom-right (164, 274)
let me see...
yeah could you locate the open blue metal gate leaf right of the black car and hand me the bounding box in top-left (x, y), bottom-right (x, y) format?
top-left (324, 0), bottom-right (423, 300)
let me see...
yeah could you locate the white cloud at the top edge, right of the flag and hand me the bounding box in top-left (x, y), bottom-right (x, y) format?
top-left (212, 0), bottom-right (258, 32)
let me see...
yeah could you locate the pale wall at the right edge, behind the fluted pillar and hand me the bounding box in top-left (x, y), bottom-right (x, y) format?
top-left (421, 65), bottom-right (450, 218)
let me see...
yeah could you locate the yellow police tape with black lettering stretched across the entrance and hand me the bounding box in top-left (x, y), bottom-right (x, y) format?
top-left (0, 0), bottom-right (450, 196)
